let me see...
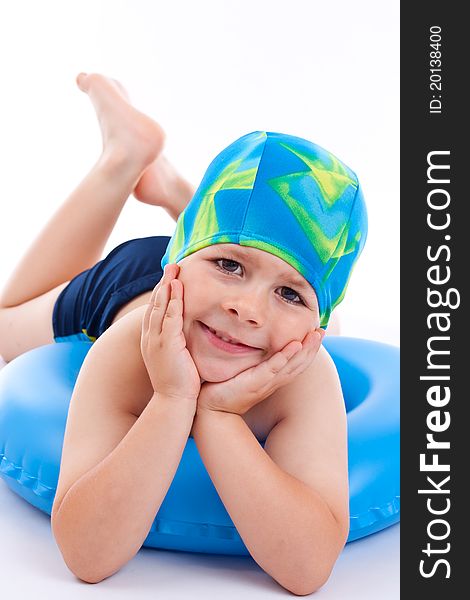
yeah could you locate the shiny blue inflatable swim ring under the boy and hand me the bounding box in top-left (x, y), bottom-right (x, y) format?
top-left (0, 336), bottom-right (400, 555)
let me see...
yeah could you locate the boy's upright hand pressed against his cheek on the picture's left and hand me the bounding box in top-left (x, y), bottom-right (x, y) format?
top-left (140, 263), bottom-right (201, 407)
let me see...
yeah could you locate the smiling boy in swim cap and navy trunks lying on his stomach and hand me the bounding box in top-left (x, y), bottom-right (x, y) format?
top-left (0, 74), bottom-right (366, 595)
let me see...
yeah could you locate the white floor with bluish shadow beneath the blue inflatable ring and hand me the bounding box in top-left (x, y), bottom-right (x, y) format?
top-left (0, 479), bottom-right (400, 600)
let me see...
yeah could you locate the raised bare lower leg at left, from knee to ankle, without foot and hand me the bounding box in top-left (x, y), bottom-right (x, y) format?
top-left (0, 157), bottom-right (146, 307)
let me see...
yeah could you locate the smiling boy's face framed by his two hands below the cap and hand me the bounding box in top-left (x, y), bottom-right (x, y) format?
top-left (174, 244), bottom-right (320, 382)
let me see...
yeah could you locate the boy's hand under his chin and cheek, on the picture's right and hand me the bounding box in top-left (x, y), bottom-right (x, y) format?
top-left (197, 329), bottom-right (325, 415)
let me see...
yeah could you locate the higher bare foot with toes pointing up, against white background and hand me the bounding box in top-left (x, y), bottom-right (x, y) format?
top-left (76, 73), bottom-right (165, 169)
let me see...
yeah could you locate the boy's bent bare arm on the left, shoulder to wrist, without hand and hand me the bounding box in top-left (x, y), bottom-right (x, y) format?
top-left (51, 307), bottom-right (196, 583)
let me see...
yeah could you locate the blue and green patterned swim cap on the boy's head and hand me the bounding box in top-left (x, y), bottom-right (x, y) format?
top-left (161, 131), bottom-right (367, 328)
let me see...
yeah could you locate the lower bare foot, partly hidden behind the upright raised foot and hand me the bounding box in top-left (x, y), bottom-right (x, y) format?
top-left (133, 154), bottom-right (194, 216)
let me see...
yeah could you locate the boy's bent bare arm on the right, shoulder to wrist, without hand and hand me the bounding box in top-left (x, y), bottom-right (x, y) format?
top-left (193, 348), bottom-right (349, 595)
